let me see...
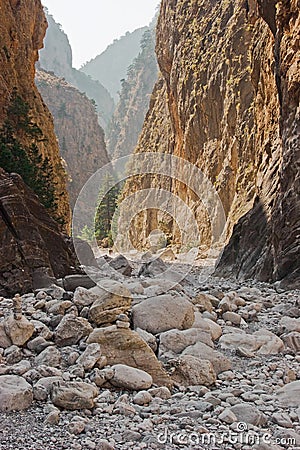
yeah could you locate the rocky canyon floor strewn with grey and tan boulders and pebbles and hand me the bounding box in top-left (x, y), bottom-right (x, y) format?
top-left (0, 255), bottom-right (300, 450)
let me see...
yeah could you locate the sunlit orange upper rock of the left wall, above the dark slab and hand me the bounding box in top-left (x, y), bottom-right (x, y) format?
top-left (0, 0), bottom-right (70, 229)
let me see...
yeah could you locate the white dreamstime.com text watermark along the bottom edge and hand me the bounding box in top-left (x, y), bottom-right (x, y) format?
top-left (157, 422), bottom-right (296, 450)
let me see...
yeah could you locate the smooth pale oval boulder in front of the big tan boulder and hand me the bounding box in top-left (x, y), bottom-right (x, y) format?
top-left (110, 364), bottom-right (152, 391)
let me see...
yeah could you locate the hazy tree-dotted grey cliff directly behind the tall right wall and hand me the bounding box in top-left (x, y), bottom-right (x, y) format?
top-left (107, 27), bottom-right (158, 158)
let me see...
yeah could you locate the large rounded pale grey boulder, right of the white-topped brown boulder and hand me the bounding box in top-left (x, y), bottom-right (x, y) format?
top-left (132, 294), bottom-right (194, 334)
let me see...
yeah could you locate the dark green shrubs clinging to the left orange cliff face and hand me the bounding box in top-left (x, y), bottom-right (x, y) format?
top-left (0, 90), bottom-right (62, 223)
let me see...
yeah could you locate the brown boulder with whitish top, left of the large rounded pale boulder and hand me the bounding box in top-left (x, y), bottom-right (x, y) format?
top-left (89, 280), bottom-right (131, 325)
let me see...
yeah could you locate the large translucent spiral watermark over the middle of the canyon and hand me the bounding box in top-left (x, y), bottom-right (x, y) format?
top-left (72, 153), bottom-right (226, 288)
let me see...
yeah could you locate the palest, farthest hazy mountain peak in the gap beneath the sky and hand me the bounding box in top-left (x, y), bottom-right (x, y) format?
top-left (80, 27), bottom-right (149, 101)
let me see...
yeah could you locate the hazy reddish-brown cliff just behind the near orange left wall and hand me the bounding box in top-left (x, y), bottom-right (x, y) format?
top-left (36, 71), bottom-right (108, 207)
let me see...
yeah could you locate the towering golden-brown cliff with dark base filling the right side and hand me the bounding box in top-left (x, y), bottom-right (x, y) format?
top-left (125, 0), bottom-right (300, 281)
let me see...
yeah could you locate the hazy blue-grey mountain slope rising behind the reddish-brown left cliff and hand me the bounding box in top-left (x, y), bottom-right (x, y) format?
top-left (38, 8), bottom-right (114, 129)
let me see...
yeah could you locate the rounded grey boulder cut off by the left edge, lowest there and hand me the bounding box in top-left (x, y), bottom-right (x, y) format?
top-left (0, 375), bottom-right (33, 412)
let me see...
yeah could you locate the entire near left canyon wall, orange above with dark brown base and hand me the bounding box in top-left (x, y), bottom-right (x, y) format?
top-left (0, 0), bottom-right (78, 296)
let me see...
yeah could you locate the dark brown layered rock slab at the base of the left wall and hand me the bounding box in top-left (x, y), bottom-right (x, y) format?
top-left (0, 168), bottom-right (78, 296)
